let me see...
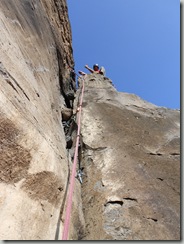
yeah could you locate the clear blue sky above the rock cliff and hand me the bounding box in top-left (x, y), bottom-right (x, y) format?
top-left (67, 0), bottom-right (180, 109)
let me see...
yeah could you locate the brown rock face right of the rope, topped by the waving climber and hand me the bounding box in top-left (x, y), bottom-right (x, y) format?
top-left (77, 74), bottom-right (180, 240)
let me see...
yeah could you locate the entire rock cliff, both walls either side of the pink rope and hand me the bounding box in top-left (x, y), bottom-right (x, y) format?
top-left (0, 0), bottom-right (180, 240)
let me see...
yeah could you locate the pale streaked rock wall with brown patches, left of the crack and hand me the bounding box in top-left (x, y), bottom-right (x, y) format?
top-left (0, 0), bottom-right (81, 240)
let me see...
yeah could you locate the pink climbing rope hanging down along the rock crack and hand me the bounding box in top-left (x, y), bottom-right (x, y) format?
top-left (62, 72), bottom-right (86, 240)
